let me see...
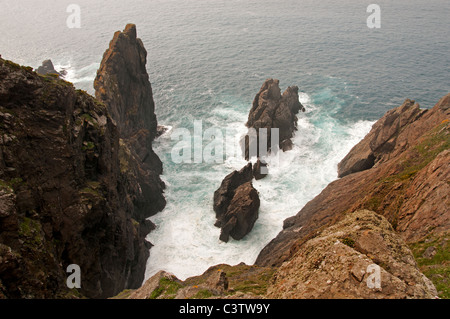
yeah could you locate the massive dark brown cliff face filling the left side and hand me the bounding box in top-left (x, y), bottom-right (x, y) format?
top-left (0, 51), bottom-right (160, 298)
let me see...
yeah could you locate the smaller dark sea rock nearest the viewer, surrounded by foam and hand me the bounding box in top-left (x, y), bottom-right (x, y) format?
top-left (213, 163), bottom-right (260, 242)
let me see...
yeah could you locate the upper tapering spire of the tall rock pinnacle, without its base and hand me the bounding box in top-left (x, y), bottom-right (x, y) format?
top-left (94, 24), bottom-right (162, 173)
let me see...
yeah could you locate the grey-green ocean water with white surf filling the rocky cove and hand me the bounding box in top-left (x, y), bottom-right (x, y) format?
top-left (0, 0), bottom-right (450, 279)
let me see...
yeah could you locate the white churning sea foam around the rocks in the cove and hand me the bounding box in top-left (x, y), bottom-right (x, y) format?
top-left (146, 93), bottom-right (372, 279)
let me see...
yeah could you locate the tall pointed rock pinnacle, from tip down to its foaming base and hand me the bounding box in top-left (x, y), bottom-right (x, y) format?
top-left (94, 24), bottom-right (166, 216)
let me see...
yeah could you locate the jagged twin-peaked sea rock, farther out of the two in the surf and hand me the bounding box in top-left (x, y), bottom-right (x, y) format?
top-left (244, 79), bottom-right (305, 160)
